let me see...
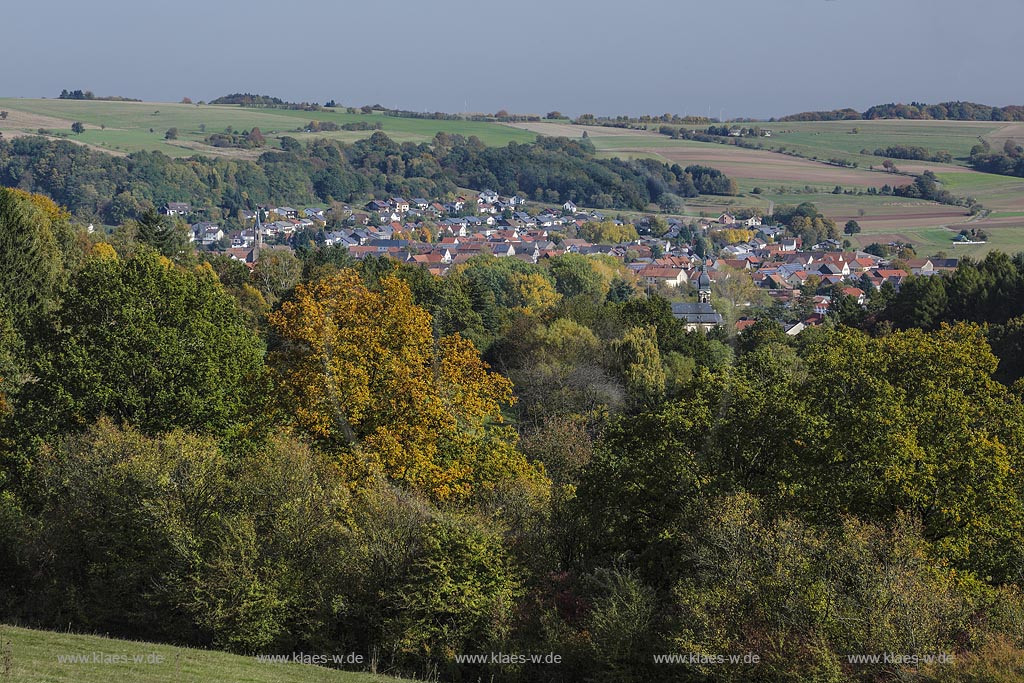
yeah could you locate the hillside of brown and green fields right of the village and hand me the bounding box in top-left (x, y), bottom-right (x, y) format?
top-left (515, 120), bottom-right (1024, 257)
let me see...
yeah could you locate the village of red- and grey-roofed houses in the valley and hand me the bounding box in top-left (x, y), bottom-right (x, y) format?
top-left (162, 189), bottom-right (957, 335)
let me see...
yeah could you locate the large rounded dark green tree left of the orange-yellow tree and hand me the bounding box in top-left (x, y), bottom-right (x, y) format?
top-left (18, 250), bottom-right (263, 434)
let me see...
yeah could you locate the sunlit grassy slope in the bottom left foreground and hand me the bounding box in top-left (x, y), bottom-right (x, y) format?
top-left (0, 626), bottom-right (411, 683)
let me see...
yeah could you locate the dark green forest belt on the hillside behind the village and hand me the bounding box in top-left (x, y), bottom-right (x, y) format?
top-left (0, 129), bottom-right (735, 225)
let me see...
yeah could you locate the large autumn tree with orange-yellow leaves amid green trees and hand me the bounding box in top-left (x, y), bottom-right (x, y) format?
top-left (269, 269), bottom-right (544, 502)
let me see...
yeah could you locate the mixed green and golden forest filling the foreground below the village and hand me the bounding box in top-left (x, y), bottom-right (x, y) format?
top-left (0, 184), bottom-right (1024, 683)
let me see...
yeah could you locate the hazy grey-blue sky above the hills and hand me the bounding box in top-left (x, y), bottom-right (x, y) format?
top-left (0, 0), bottom-right (1024, 117)
